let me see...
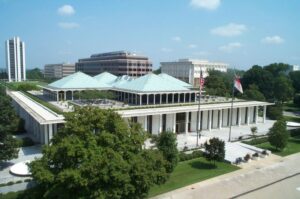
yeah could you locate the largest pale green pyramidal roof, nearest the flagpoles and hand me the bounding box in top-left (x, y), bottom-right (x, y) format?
top-left (116, 73), bottom-right (189, 92)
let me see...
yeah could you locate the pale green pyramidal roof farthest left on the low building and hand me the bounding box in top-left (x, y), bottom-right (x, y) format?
top-left (48, 71), bottom-right (109, 89)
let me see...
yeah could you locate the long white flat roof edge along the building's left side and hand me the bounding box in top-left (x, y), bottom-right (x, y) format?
top-left (9, 91), bottom-right (65, 124)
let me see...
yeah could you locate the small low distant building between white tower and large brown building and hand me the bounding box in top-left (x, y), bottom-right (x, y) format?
top-left (44, 63), bottom-right (75, 79)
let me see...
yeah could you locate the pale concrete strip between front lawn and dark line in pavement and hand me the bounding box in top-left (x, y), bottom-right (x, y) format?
top-left (154, 153), bottom-right (300, 199)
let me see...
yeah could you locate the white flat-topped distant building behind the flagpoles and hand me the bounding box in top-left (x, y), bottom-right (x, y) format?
top-left (160, 59), bottom-right (228, 86)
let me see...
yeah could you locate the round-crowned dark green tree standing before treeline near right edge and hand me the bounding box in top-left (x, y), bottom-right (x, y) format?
top-left (274, 75), bottom-right (294, 103)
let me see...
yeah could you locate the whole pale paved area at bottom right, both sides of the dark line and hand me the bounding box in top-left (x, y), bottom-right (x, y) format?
top-left (154, 153), bottom-right (300, 199)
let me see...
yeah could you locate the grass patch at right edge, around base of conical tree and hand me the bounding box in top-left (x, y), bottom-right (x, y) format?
top-left (255, 135), bottom-right (300, 156)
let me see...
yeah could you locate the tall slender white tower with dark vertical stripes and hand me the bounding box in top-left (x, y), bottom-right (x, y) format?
top-left (5, 37), bottom-right (26, 82)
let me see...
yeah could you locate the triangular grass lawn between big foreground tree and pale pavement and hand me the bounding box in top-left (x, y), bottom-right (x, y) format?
top-left (149, 157), bottom-right (239, 197)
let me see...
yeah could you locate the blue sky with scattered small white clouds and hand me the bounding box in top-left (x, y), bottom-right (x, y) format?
top-left (0, 0), bottom-right (300, 69)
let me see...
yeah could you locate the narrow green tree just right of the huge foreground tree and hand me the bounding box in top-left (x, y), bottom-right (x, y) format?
top-left (155, 131), bottom-right (178, 173)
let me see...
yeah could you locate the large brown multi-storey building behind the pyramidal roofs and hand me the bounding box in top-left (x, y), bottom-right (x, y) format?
top-left (75, 51), bottom-right (152, 77)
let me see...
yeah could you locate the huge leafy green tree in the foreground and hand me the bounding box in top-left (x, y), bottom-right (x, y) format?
top-left (30, 107), bottom-right (168, 198)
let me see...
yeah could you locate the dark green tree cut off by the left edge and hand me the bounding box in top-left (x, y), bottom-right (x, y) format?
top-left (0, 86), bottom-right (19, 162)
